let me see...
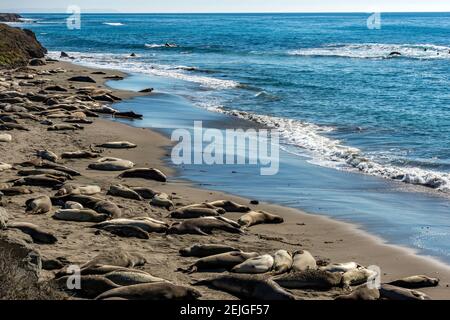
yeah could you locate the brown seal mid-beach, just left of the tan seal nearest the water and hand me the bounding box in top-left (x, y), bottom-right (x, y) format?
top-left (167, 218), bottom-right (243, 236)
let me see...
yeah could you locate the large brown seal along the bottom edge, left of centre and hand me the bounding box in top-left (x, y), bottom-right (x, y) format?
top-left (96, 282), bottom-right (201, 300)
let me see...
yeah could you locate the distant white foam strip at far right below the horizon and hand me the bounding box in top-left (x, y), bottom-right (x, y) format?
top-left (288, 43), bottom-right (450, 59)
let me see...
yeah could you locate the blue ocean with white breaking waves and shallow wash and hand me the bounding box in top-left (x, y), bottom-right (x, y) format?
top-left (13, 13), bottom-right (450, 263)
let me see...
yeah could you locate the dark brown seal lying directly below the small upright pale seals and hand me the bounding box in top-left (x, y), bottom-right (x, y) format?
top-left (273, 269), bottom-right (342, 290)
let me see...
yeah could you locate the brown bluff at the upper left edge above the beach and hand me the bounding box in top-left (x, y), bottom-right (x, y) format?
top-left (0, 24), bottom-right (47, 68)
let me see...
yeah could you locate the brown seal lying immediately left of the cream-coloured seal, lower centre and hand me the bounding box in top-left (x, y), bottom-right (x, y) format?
top-left (177, 251), bottom-right (258, 273)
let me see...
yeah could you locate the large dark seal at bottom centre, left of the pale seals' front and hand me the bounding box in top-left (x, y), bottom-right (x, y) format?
top-left (193, 274), bottom-right (295, 300)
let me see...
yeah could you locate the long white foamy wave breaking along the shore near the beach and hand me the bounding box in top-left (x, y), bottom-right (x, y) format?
top-left (199, 103), bottom-right (450, 192)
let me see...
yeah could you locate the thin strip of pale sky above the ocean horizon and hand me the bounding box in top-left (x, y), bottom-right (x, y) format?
top-left (0, 0), bottom-right (450, 13)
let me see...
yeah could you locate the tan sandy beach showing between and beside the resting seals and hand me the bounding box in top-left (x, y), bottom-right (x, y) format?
top-left (0, 62), bottom-right (450, 299)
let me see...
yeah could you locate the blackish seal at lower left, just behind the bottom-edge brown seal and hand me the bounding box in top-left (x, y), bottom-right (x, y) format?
top-left (55, 275), bottom-right (121, 299)
